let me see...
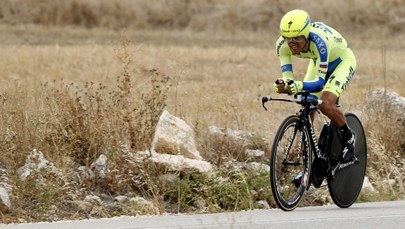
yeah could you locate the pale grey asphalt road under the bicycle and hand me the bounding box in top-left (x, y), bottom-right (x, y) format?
top-left (0, 200), bottom-right (405, 229)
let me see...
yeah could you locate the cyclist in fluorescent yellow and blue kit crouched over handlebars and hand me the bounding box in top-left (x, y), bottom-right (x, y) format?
top-left (273, 9), bottom-right (357, 163)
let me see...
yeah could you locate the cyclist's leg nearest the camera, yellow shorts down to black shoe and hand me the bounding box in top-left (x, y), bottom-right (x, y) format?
top-left (320, 49), bottom-right (356, 162)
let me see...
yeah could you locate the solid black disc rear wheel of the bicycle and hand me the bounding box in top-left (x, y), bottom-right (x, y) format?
top-left (328, 113), bottom-right (367, 208)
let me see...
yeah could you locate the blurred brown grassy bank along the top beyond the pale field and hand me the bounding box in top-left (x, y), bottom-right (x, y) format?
top-left (0, 0), bottom-right (405, 38)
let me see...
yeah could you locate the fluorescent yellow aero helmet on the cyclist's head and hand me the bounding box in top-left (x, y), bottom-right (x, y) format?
top-left (280, 10), bottom-right (311, 38)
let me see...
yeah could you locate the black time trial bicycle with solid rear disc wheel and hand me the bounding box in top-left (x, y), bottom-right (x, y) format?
top-left (262, 92), bottom-right (367, 211)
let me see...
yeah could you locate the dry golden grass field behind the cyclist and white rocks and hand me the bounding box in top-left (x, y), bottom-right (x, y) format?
top-left (0, 0), bottom-right (405, 222)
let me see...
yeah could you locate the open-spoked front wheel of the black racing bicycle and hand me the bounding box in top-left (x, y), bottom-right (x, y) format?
top-left (270, 115), bottom-right (311, 211)
